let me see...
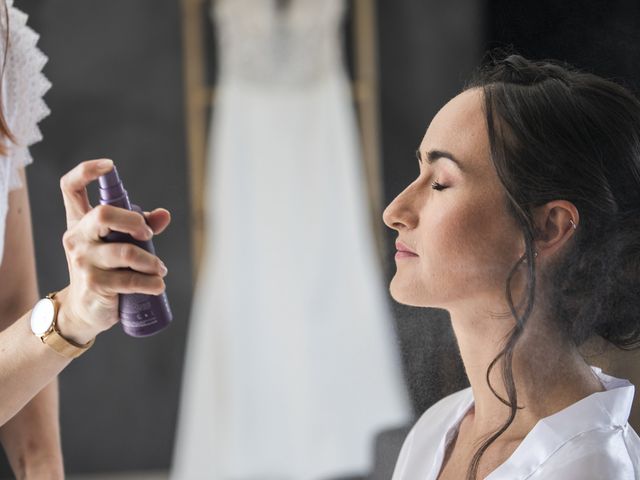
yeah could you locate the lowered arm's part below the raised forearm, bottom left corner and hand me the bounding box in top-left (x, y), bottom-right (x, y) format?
top-left (0, 379), bottom-right (64, 479)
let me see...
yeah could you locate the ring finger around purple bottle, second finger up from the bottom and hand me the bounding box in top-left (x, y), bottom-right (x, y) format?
top-left (91, 243), bottom-right (167, 277)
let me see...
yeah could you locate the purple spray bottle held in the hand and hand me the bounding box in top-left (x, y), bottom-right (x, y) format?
top-left (98, 165), bottom-right (173, 337)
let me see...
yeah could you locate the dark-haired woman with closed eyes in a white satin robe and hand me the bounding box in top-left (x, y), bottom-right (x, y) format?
top-left (384, 55), bottom-right (640, 480)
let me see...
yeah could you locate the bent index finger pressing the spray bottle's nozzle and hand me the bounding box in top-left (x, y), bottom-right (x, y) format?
top-left (60, 159), bottom-right (113, 228)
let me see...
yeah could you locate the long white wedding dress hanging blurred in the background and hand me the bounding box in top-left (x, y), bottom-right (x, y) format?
top-left (172, 0), bottom-right (411, 480)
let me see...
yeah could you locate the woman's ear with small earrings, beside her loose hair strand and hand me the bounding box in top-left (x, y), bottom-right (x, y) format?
top-left (533, 200), bottom-right (580, 257)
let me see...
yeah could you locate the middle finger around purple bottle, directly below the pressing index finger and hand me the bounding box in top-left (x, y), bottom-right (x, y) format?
top-left (81, 205), bottom-right (153, 240)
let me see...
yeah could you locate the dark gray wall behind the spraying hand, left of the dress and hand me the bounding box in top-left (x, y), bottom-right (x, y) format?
top-left (3, 0), bottom-right (192, 473)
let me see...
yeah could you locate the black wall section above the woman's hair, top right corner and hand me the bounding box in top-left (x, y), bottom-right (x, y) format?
top-left (486, 0), bottom-right (640, 92)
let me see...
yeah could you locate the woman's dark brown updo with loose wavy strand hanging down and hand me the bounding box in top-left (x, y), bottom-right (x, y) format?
top-left (465, 51), bottom-right (640, 480)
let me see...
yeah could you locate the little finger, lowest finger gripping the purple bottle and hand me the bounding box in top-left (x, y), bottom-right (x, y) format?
top-left (86, 268), bottom-right (166, 296)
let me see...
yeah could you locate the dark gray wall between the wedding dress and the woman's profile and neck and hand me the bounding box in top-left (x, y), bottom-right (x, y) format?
top-left (378, 0), bottom-right (483, 413)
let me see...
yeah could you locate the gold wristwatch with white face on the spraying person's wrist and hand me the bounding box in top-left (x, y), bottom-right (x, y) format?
top-left (30, 292), bottom-right (95, 358)
